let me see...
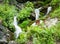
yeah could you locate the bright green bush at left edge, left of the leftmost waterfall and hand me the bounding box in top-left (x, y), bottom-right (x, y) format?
top-left (0, 4), bottom-right (16, 29)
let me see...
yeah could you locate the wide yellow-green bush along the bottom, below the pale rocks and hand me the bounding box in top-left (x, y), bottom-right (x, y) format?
top-left (17, 26), bottom-right (56, 44)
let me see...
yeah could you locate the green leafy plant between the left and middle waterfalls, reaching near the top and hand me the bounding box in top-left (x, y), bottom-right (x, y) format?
top-left (18, 2), bottom-right (34, 20)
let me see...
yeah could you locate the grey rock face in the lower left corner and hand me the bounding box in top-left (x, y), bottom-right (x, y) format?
top-left (0, 24), bottom-right (13, 44)
